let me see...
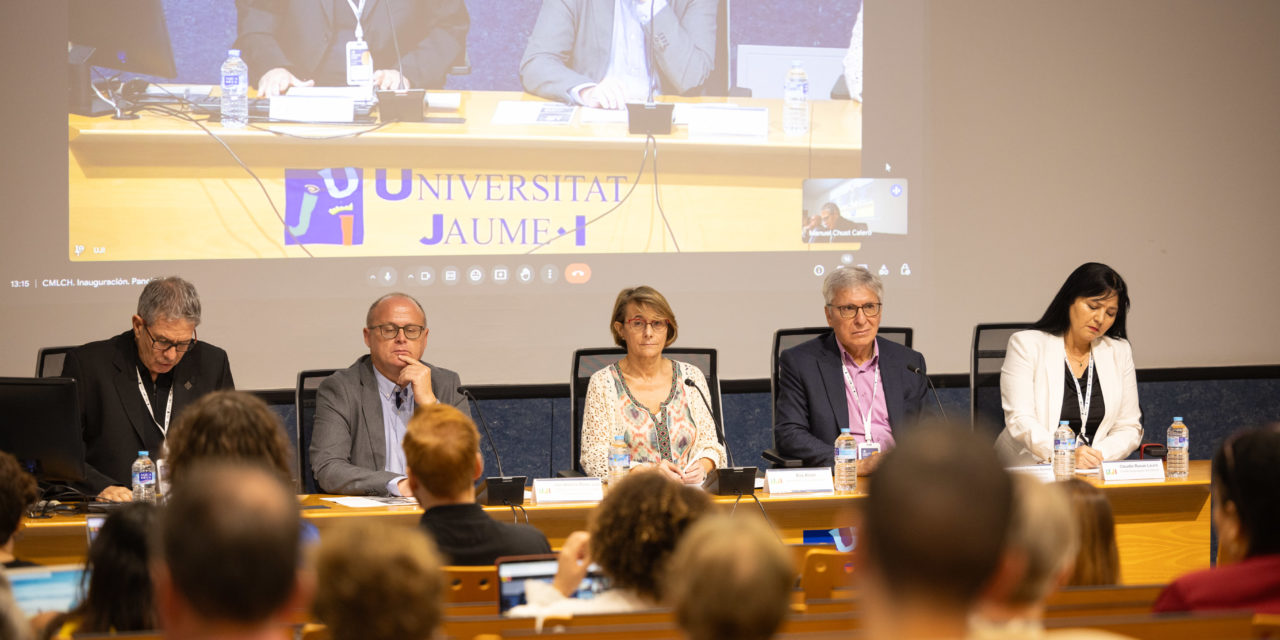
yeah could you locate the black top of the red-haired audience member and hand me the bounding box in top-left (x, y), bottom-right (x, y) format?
top-left (421, 503), bottom-right (552, 566)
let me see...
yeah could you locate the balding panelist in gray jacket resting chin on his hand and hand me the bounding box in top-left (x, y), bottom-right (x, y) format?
top-left (311, 293), bottom-right (471, 495)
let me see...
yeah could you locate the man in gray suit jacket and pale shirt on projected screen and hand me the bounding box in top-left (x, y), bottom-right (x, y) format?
top-left (520, 0), bottom-right (719, 109)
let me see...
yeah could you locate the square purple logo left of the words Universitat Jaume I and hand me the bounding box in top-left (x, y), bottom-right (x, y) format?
top-left (284, 166), bottom-right (365, 246)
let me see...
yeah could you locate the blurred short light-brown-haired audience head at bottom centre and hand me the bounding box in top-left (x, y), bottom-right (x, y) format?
top-left (666, 515), bottom-right (795, 640)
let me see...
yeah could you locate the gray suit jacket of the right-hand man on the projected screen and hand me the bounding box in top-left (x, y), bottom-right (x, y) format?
top-left (520, 0), bottom-right (719, 101)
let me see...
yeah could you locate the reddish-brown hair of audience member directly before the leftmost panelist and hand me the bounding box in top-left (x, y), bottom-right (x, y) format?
top-left (166, 392), bottom-right (293, 485)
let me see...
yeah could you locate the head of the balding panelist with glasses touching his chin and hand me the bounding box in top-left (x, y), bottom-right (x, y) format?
top-left (365, 292), bottom-right (429, 381)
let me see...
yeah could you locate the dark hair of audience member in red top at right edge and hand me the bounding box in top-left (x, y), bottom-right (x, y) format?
top-left (1213, 422), bottom-right (1280, 558)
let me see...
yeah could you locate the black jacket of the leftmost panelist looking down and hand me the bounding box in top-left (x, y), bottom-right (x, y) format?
top-left (63, 330), bottom-right (234, 494)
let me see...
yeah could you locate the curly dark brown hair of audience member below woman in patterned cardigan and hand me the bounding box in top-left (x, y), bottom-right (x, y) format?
top-left (590, 471), bottom-right (712, 600)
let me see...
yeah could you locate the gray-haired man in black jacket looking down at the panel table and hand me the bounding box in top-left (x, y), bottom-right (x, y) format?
top-left (63, 276), bottom-right (234, 502)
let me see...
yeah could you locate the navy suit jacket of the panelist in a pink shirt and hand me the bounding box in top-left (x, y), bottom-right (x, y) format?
top-left (773, 333), bottom-right (928, 467)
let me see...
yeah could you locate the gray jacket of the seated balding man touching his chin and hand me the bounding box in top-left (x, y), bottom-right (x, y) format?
top-left (311, 355), bottom-right (471, 495)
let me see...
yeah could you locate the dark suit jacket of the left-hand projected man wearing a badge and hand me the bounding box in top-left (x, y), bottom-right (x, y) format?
top-left (236, 0), bottom-right (471, 88)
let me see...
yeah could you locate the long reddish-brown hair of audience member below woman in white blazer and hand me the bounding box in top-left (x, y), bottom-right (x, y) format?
top-left (1056, 477), bottom-right (1120, 586)
